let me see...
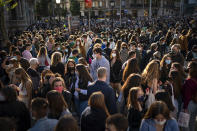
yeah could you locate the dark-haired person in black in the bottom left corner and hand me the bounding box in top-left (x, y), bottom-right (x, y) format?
top-left (0, 86), bottom-right (31, 131)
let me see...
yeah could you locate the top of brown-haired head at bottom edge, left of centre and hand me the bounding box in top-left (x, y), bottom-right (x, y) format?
top-left (55, 116), bottom-right (79, 131)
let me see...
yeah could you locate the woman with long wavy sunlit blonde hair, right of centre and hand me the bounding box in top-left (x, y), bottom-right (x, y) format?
top-left (142, 60), bottom-right (159, 94)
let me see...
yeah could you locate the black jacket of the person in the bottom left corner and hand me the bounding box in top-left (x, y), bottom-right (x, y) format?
top-left (0, 101), bottom-right (31, 131)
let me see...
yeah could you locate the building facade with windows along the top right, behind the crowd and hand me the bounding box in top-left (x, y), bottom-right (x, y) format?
top-left (79, 0), bottom-right (180, 17)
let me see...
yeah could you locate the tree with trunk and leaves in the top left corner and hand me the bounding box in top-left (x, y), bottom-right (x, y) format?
top-left (0, 0), bottom-right (18, 47)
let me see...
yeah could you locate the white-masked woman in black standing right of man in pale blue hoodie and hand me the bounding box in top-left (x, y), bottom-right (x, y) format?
top-left (110, 50), bottom-right (122, 93)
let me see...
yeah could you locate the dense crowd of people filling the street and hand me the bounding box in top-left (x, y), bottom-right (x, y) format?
top-left (0, 17), bottom-right (197, 131)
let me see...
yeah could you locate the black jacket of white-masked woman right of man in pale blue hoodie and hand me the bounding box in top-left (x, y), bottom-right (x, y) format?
top-left (110, 60), bottom-right (122, 83)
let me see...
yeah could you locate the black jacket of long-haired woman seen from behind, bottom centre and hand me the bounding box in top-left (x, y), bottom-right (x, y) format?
top-left (81, 107), bottom-right (107, 131)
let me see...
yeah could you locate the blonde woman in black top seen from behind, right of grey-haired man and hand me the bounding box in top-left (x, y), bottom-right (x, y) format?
top-left (50, 52), bottom-right (65, 77)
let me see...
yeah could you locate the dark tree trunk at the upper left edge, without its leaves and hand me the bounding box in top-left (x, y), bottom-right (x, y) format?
top-left (0, 6), bottom-right (9, 47)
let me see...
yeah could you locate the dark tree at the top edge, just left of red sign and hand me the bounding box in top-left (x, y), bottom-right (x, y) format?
top-left (70, 0), bottom-right (80, 16)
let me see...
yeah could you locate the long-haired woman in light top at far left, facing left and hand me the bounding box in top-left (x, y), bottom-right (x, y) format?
top-left (12, 68), bottom-right (32, 108)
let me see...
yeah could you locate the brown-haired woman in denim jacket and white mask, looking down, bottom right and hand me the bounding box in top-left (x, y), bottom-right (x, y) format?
top-left (140, 101), bottom-right (179, 131)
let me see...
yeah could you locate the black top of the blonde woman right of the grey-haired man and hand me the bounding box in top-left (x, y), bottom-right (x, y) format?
top-left (50, 62), bottom-right (65, 77)
